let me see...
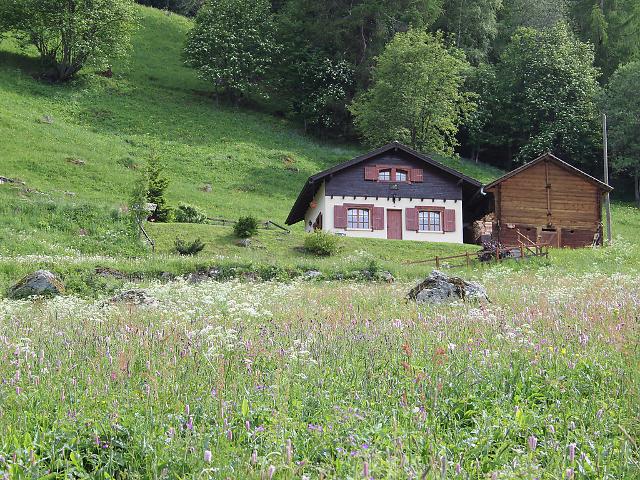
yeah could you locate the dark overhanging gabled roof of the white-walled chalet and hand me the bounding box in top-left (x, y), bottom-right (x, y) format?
top-left (286, 142), bottom-right (482, 225)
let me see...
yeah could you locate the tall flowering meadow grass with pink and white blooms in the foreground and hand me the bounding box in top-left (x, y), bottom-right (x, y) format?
top-left (0, 270), bottom-right (640, 479)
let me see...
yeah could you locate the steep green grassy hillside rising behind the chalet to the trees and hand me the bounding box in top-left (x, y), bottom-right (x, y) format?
top-left (0, 7), bottom-right (499, 253)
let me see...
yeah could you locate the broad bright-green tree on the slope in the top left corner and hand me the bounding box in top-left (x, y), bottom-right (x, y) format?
top-left (0, 0), bottom-right (136, 81)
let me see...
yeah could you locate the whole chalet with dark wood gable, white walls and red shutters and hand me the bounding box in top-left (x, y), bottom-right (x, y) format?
top-left (286, 142), bottom-right (482, 243)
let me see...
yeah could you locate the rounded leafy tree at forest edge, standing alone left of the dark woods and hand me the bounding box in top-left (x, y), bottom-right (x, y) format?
top-left (184, 0), bottom-right (278, 100)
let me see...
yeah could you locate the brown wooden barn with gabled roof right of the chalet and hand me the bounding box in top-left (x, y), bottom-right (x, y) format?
top-left (484, 153), bottom-right (612, 248)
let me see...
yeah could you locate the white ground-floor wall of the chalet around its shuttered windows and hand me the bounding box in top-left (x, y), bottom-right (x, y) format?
top-left (322, 192), bottom-right (462, 243)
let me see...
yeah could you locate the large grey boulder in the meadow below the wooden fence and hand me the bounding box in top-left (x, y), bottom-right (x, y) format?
top-left (407, 270), bottom-right (489, 303)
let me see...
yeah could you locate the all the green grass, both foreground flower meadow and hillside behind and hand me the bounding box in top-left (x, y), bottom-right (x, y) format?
top-left (0, 3), bottom-right (640, 480)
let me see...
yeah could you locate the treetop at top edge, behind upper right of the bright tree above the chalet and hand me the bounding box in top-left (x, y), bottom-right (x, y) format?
top-left (435, 0), bottom-right (502, 65)
